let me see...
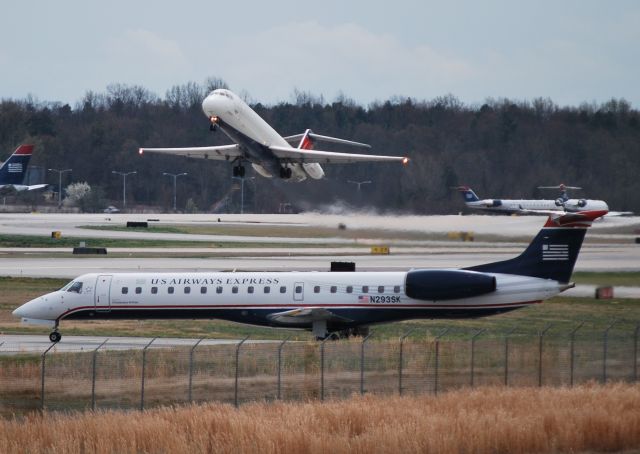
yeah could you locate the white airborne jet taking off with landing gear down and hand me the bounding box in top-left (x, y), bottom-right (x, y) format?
top-left (139, 89), bottom-right (409, 181)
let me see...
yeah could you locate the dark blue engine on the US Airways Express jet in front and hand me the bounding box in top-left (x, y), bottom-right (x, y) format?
top-left (405, 270), bottom-right (496, 301)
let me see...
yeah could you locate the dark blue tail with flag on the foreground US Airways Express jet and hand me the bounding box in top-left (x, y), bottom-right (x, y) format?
top-left (465, 210), bottom-right (607, 283)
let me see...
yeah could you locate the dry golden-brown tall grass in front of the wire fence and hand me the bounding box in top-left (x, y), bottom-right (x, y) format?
top-left (0, 384), bottom-right (640, 453)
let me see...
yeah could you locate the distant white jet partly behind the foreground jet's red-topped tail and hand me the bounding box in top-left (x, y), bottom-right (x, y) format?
top-left (456, 186), bottom-right (609, 214)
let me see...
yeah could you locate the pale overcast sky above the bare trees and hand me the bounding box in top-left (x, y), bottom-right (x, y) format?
top-left (0, 0), bottom-right (640, 108)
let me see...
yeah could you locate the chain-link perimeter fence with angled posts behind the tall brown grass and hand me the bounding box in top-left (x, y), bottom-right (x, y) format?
top-left (0, 323), bottom-right (640, 416)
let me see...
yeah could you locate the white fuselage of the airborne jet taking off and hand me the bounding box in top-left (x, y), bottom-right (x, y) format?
top-left (202, 89), bottom-right (324, 181)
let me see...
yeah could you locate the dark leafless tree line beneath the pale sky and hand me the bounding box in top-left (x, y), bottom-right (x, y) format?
top-left (0, 78), bottom-right (640, 213)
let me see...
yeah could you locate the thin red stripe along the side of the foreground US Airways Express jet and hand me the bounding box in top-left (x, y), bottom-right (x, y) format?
top-left (61, 300), bottom-right (542, 317)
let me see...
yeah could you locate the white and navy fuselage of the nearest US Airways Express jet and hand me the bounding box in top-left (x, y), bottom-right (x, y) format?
top-left (14, 271), bottom-right (564, 331)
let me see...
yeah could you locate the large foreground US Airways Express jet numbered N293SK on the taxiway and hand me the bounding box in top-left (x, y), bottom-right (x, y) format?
top-left (13, 211), bottom-right (605, 342)
